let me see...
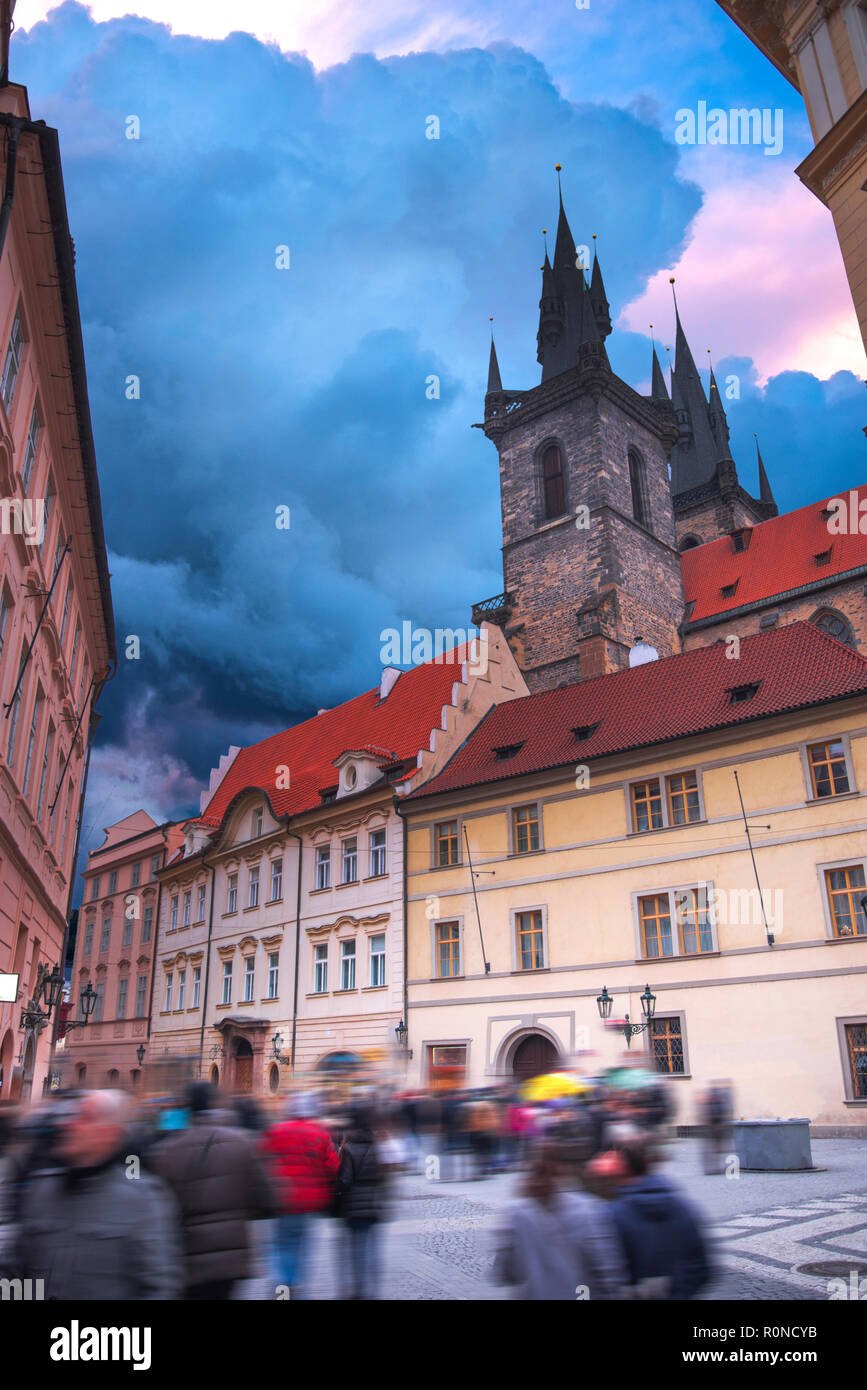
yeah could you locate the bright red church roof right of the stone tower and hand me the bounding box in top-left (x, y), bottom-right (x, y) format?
top-left (681, 484), bottom-right (867, 623)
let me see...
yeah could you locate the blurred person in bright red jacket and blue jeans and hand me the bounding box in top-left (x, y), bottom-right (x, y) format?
top-left (261, 1094), bottom-right (339, 1298)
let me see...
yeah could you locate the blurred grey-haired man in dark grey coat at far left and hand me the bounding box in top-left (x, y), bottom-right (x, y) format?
top-left (0, 1090), bottom-right (182, 1302)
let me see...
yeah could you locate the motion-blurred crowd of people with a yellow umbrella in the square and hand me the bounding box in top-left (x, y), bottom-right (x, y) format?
top-left (0, 1072), bottom-right (731, 1301)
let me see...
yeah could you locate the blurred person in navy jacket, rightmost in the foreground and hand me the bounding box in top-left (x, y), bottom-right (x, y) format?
top-left (610, 1138), bottom-right (711, 1300)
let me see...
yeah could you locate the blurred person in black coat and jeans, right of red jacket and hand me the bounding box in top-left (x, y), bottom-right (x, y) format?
top-left (336, 1106), bottom-right (389, 1298)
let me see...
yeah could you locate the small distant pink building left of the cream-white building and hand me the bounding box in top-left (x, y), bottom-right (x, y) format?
top-left (62, 810), bottom-right (182, 1090)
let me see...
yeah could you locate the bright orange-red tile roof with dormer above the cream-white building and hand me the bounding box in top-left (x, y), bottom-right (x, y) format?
top-left (200, 646), bottom-right (464, 826)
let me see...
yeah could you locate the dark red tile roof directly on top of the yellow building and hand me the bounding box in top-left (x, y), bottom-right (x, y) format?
top-left (407, 623), bottom-right (867, 802)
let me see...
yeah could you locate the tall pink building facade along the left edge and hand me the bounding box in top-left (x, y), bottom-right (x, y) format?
top-left (0, 76), bottom-right (115, 1104)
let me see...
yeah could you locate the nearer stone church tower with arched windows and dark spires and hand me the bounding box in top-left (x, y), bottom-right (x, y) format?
top-left (474, 190), bottom-right (684, 689)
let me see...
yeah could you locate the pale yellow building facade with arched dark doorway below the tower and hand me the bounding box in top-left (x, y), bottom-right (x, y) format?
top-left (402, 639), bottom-right (867, 1133)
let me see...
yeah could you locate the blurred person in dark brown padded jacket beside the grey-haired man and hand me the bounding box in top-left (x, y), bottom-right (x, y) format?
top-left (151, 1081), bottom-right (276, 1300)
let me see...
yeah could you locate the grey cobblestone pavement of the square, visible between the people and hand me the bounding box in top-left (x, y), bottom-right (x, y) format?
top-left (240, 1140), bottom-right (867, 1301)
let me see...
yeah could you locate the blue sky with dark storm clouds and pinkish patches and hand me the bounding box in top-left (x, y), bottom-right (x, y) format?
top-left (13, 0), bottom-right (866, 845)
